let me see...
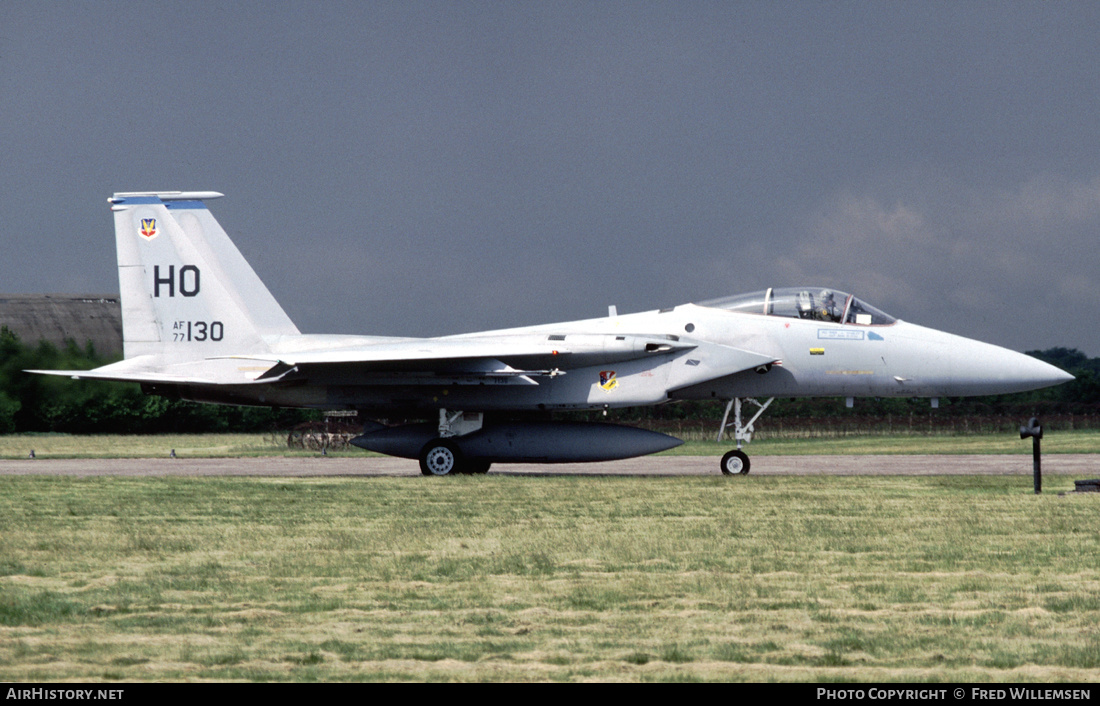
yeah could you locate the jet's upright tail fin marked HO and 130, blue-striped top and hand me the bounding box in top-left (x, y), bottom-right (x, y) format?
top-left (110, 191), bottom-right (298, 362)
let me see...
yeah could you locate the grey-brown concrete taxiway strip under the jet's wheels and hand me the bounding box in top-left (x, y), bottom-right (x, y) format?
top-left (0, 454), bottom-right (1100, 478)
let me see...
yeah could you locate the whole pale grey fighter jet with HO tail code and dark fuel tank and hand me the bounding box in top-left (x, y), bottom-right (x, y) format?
top-left (31, 191), bottom-right (1073, 475)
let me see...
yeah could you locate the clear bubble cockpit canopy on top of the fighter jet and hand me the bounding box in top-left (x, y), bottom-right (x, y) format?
top-left (700, 287), bottom-right (897, 326)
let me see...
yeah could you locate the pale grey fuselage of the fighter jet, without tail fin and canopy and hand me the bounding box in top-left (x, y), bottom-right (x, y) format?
top-left (149, 304), bottom-right (1069, 412)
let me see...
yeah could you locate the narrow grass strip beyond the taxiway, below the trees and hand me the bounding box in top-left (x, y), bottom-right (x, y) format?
top-left (0, 430), bottom-right (1100, 459)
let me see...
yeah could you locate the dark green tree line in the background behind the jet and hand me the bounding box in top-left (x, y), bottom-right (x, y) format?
top-left (0, 327), bottom-right (1100, 433)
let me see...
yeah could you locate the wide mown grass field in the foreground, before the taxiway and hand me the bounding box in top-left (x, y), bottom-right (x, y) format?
top-left (0, 470), bottom-right (1100, 682)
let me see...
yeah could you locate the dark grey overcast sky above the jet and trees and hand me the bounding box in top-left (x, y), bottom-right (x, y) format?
top-left (0, 2), bottom-right (1100, 355)
